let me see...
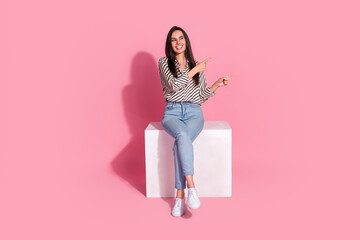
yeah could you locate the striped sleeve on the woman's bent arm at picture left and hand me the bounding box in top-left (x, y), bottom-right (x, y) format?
top-left (159, 57), bottom-right (190, 92)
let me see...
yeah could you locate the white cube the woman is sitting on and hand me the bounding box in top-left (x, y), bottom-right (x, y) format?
top-left (145, 121), bottom-right (232, 197)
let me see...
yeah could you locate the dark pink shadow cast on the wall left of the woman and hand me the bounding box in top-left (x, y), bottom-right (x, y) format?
top-left (111, 52), bottom-right (166, 196)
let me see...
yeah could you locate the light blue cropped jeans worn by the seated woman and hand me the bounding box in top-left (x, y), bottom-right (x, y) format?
top-left (161, 102), bottom-right (204, 189)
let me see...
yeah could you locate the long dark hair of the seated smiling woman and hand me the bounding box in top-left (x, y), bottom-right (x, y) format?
top-left (165, 26), bottom-right (200, 85)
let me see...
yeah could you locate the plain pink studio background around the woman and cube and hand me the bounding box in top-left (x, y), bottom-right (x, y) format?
top-left (0, 0), bottom-right (360, 240)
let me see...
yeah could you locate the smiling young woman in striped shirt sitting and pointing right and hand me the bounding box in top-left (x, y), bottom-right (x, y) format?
top-left (159, 26), bottom-right (230, 216)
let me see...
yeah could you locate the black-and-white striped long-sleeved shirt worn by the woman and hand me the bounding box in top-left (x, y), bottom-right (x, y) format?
top-left (159, 57), bottom-right (216, 105)
